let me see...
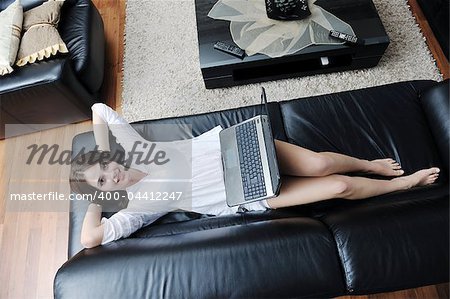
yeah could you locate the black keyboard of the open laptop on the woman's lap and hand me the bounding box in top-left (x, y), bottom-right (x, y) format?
top-left (236, 120), bottom-right (267, 200)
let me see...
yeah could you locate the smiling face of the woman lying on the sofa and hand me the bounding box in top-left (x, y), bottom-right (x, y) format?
top-left (84, 161), bottom-right (132, 191)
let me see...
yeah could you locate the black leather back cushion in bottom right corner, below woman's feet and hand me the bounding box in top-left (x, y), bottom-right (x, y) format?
top-left (320, 183), bottom-right (449, 295)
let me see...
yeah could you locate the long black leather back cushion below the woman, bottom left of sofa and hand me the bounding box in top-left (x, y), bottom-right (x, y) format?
top-left (55, 217), bottom-right (345, 298)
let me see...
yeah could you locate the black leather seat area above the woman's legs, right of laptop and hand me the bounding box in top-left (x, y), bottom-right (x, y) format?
top-left (280, 81), bottom-right (446, 179)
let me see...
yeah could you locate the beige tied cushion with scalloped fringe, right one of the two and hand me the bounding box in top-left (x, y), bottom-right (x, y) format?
top-left (16, 0), bottom-right (69, 66)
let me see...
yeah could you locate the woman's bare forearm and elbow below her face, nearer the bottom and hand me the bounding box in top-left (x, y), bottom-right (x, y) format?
top-left (81, 203), bottom-right (104, 248)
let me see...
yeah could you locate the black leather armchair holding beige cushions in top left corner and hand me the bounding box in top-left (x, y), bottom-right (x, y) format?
top-left (0, 0), bottom-right (105, 139)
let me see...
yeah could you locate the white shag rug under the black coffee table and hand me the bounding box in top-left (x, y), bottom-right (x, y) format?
top-left (122, 0), bottom-right (442, 122)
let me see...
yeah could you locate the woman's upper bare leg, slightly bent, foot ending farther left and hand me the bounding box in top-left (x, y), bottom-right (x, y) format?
top-left (275, 140), bottom-right (403, 177)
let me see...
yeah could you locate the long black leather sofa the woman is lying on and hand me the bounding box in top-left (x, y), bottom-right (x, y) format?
top-left (54, 81), bottom-right (450, 298)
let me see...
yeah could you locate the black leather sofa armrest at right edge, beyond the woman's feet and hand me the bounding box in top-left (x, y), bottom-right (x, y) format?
top-left (419, 80), bottom-right (450, 173)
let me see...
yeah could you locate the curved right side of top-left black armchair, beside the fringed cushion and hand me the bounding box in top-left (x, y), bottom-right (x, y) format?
top-left (58, 0), bottom-right (105, 94)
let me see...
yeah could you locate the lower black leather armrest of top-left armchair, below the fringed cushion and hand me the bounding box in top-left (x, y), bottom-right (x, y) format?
top-left (0, 57), bottom-right (94, 139)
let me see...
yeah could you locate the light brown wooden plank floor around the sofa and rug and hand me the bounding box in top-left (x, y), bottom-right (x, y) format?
top-left (0, 0), bottom-right (449, 299)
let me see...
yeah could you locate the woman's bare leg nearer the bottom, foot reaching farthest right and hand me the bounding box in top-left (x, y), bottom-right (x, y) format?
top-left (267, 167), bottom-right (439, 209)
